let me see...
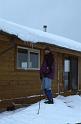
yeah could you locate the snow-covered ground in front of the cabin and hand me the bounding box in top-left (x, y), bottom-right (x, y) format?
top-left (0, 95), bottom-right (81, 124)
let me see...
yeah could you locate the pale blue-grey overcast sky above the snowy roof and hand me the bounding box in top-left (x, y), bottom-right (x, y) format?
top-left (0, 0), bottom-right (81, 41)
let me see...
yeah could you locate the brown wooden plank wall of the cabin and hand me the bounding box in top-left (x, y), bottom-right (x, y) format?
top-left (0, 32), bottom-right (81, 109)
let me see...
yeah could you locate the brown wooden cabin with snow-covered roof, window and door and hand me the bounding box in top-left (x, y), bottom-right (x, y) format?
top-left (0, 19), bottom-right (81, 108)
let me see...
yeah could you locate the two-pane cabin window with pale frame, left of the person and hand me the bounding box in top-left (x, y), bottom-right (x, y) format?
top-left (17, 47), bottom-right (40, 70)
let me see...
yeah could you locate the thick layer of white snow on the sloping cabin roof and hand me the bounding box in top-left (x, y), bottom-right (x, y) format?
top-left (0, 19), bottom-right (81, 52)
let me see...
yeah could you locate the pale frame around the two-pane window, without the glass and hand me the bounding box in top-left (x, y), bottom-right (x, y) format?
top-left (16, 46), bottom-right (40, 70)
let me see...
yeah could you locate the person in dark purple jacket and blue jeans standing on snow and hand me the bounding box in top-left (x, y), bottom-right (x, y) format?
top-left (40, 47), bottom-right (55, 104)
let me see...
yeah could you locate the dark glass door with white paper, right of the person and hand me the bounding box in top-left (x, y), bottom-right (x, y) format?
top-left (64, 57), bottom-right (78, 91)
